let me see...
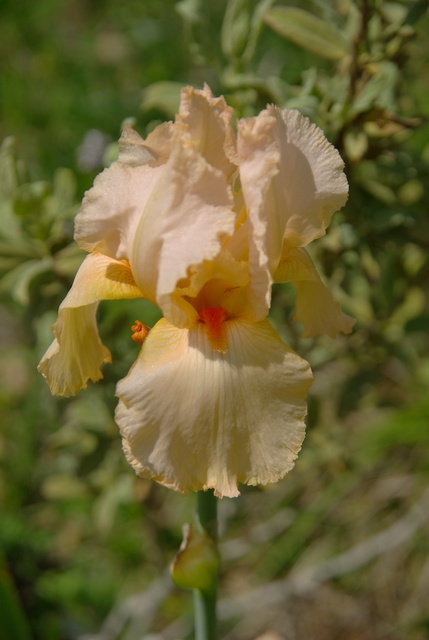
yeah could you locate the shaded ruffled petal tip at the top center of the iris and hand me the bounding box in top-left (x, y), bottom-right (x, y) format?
top-left (176, 85), bottom-right (237, 181)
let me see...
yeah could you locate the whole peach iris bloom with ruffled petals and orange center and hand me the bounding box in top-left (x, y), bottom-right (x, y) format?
top-left (39, 86), bottom-right (353, 497)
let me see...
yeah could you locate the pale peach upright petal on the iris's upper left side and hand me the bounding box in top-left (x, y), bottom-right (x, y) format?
top-left (75, 123), bottom-right (166, 260)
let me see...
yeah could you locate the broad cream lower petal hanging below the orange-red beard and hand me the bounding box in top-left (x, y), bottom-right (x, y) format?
top-left (116, 319), bottom-right (312, 497)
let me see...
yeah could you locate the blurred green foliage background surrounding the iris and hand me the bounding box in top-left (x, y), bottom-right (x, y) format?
top-left (0, 0), bottom-right (429, 640)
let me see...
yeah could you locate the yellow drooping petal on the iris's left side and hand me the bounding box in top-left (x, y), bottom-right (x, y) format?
top-left (38, 253), bottom-right (142, 396)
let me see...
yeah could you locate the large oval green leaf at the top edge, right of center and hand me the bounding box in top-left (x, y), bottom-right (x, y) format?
top-left (264, 7), bottom-right (350, 60)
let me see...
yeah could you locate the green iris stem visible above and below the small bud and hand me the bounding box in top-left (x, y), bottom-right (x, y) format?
top-left (194, 491), bottom-right (218, 640)
